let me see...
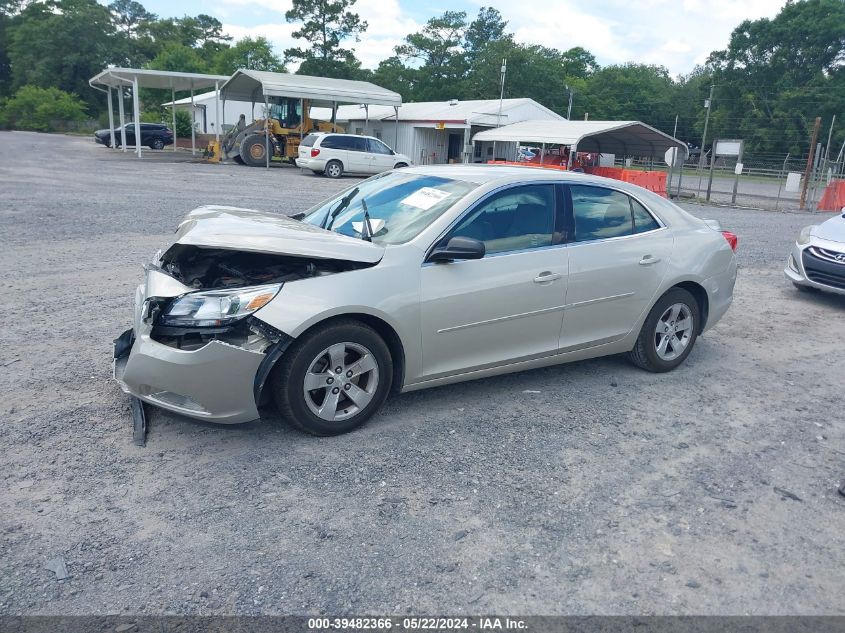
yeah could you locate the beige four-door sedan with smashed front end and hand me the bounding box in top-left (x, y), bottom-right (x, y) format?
top-left (115, 165), bottom-right (736, 435)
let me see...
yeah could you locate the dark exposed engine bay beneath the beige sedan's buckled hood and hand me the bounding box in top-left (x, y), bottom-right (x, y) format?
top-left (160, 244), bottom-right (371, 290)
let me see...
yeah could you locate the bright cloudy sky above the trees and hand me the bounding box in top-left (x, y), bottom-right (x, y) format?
top-left (137, 0), bottom-right (785, 74)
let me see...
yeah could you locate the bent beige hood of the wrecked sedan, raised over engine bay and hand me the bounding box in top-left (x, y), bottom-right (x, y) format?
top-left (175, 206), bottom-right (384, 264)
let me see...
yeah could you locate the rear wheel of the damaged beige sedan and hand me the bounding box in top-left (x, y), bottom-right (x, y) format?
top-left (629, 288), bottom-right (701, 372)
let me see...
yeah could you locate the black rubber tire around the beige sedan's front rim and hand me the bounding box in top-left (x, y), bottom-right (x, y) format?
top-left (271, 320), bottom-right (393, 436)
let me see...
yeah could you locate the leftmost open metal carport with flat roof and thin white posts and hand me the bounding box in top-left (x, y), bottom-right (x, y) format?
top-left (88, 68), bottom-right (228, 158)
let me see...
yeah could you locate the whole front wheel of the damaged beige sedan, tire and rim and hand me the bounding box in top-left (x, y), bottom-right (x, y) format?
top-left (272, 321), bottom-right (393, 435)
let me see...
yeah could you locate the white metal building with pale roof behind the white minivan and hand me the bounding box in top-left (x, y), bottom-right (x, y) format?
top-left (320, 98), bottom-right (566, 165)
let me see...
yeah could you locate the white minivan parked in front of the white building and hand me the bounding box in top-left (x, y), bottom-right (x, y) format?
top-left (296, 132), bottom-right (411, 178)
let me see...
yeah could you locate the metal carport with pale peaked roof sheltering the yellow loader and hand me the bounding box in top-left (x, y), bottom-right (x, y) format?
top-left (220, 68), bottom-right (402, 167)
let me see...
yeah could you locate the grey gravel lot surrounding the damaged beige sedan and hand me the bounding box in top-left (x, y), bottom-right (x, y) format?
top-left (0, 132), bottom-right (845, 615)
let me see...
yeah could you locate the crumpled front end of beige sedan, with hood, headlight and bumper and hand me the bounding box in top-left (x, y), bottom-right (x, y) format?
top-left (114, 222), bottom-right (382, 424)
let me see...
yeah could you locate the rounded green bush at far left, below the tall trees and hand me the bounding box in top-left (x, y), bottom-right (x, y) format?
top-left (0, 86), bottom-right (85, 132)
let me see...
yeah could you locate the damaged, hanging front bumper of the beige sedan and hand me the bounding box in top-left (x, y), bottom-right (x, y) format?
top-left (114, 269), bottom-right (284, 424)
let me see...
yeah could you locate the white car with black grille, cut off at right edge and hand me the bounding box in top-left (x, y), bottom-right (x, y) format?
top-left (783, 209), bottom-right (845, 295)
